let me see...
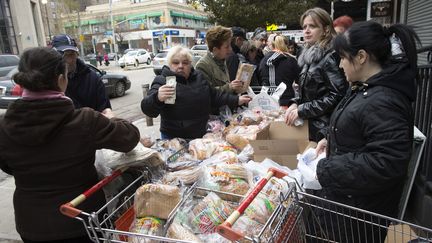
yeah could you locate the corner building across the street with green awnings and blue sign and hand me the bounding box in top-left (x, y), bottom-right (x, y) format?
top-left (63, 0), bottom-right (211, 53)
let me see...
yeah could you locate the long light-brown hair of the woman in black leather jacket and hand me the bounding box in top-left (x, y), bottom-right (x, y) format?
top-left (300, 8), bottom-right (336, 48)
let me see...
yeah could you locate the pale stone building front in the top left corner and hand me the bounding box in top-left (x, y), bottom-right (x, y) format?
top-left (0, 0), bottom-right (45, 54)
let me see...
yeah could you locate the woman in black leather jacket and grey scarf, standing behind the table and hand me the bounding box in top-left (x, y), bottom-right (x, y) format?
top-left (286, 8), bottom-right (348, 142)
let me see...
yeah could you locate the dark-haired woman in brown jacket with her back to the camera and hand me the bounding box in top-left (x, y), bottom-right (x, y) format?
top-left (0, 47), bottom-right (139, 242)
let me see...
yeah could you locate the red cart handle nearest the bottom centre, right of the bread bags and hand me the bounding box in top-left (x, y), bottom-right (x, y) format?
top-left (216, 167), bottom-right (288, 241)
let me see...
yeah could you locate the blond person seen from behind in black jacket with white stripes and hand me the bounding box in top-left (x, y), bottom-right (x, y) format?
top-left (259, 35), bottom-right (300, 106)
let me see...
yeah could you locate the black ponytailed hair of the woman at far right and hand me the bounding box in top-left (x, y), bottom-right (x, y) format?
top-left (333, 21), bottom-right (420, 69)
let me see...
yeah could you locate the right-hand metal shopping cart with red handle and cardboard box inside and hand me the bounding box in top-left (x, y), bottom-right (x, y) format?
top-left (218, 169), bottom-right (432, 243)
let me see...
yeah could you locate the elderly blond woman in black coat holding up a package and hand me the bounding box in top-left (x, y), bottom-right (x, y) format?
top-left (141, 46), bottom-right (250, 139)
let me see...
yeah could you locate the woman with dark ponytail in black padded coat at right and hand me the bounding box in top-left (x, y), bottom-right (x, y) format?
top-left (317, 21), bottom-right (418, 242)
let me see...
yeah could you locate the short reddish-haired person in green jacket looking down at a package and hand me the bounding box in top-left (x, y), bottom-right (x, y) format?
top-left (196, 26), bottom-right (243, 94)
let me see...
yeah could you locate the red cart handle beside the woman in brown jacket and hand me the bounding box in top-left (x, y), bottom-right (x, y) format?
top-left (60, 167), bottom-right (127, 218)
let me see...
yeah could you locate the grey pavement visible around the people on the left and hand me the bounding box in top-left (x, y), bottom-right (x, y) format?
top-left (0, 65), bottom-right (159, 243)
